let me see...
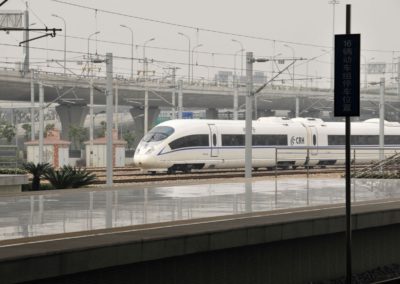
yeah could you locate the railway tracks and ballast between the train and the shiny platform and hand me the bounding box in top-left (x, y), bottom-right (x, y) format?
top-left (88, 166), bottom-right (360, 184)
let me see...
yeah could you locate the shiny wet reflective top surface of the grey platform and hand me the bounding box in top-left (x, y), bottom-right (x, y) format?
top-left (0, 178), bottom-right (400, 240)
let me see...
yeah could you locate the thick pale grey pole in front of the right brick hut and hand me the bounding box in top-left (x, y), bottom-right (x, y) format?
top-left (106, 53), bottom-right (114, 186)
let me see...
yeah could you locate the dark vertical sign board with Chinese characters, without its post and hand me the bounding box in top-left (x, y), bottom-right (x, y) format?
top-left (334, 34), bottom-right (360, 116)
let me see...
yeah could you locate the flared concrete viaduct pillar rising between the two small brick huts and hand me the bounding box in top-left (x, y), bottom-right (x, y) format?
top-left (56, 104), bottom-right (89, 140)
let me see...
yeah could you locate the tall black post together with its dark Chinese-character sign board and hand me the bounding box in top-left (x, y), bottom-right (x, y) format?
top-left (334, 5), bottom-right (360, 284)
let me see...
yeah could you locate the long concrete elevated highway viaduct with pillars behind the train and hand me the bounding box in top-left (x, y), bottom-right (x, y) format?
top-left (0, 69), bottom-right (400, 139)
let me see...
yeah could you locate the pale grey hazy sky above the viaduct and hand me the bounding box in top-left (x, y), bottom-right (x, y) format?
top-left (0, 0), bottom-right (400, 87)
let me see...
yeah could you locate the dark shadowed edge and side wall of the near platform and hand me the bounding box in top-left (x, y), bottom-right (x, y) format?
top-left (0, 199), bottom-right (400, 284)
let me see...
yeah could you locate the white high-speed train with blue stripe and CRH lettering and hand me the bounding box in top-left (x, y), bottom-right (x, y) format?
top-left (134, 117), bottom-right (400, 173)
